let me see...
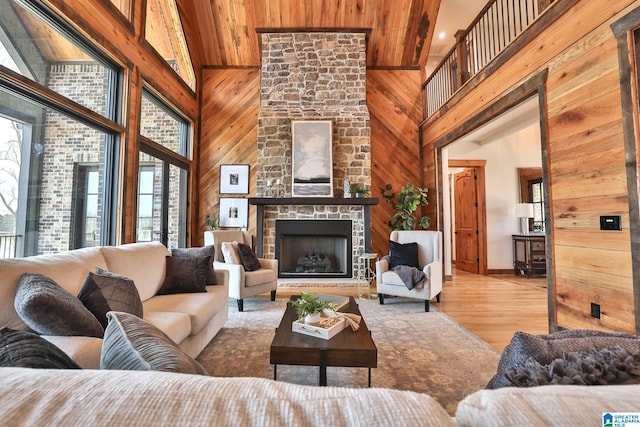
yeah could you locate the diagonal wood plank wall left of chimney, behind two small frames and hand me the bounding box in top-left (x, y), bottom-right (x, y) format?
top-left (199, 68), bottom-right (260, 246)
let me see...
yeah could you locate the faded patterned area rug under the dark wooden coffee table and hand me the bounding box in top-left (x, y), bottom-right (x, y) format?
top-left (197, 292), bottom-right (500, 415)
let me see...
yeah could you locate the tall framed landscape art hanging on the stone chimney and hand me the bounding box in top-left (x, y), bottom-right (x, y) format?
top-left (291, 120), bottom-right (333, 197)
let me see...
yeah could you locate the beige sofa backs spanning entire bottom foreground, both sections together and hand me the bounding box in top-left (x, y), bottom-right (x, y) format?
top-left (0, 368), bottom-right (640, 427)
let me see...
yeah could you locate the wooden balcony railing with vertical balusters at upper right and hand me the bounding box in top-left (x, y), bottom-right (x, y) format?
top-left (425, 0), bottom-right (553, 117)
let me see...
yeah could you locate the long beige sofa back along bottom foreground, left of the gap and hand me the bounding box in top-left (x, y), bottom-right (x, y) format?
top-left (0, 368), bottom-right (454, 427)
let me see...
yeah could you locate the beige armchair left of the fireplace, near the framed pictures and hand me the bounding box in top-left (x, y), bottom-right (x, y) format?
top-left (205, 230), bottom-right (278, 311)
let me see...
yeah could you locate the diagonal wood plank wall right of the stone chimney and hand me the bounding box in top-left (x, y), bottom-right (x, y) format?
top-left (367, 69), bottom-right (428, 256)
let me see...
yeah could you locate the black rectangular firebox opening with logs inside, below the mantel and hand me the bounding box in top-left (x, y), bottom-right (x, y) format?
top-left (276, 220), bottom-right (352, 278)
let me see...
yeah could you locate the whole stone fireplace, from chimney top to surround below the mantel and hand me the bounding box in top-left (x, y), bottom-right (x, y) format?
top-left (256, 32), bottom-right (377, 277)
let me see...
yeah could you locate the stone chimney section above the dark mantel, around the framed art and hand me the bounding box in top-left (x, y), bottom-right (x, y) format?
top-left (256, 32), bottom-right (371, 197)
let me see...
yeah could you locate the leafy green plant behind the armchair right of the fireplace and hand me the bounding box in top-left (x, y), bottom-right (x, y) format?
top-left (380, 183), bottom-right (431, 230)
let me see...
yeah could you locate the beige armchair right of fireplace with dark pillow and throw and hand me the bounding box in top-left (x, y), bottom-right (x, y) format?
top-left (376, 230), bottom-right (442, 311)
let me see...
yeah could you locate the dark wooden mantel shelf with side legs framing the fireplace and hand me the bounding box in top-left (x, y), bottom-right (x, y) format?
top-left (249, 197), bottom-right (378, 257)
